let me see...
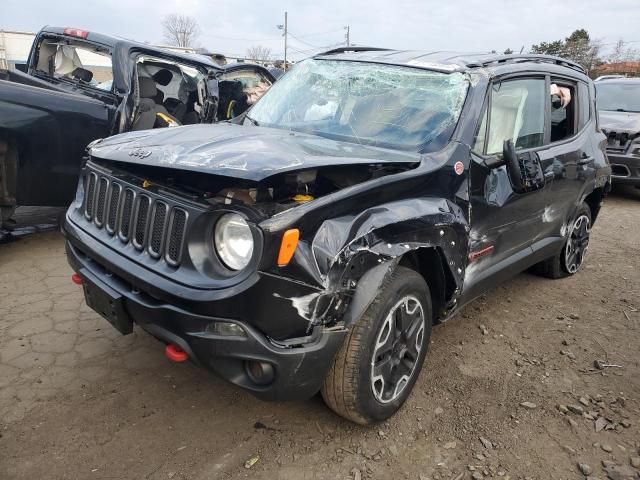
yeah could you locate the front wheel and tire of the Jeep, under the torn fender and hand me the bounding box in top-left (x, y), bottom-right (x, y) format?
top-left (322, 266), bottom-right (432, 424)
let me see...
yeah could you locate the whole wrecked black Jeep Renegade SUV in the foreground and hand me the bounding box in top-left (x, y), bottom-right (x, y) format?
top-left (64, 47), bottom-right (611, 423)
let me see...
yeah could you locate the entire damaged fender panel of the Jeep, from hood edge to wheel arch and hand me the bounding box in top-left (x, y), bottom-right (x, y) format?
top-left (254, 145), bottom-right (469, 334)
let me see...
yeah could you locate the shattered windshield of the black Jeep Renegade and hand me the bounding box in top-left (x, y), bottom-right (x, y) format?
top-left (249, 59), bottom-right (468, 152)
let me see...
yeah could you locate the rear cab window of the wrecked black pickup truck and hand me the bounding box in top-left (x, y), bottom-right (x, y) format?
top-left (37, 39), bottom-right (113, 91)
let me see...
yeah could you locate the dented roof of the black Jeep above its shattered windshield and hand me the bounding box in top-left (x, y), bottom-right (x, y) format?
top-left (315, 47), bottom-right (586, 74)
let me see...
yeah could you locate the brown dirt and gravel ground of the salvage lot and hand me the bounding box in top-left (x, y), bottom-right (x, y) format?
top-left (0, 191), bottom-right (640, 480)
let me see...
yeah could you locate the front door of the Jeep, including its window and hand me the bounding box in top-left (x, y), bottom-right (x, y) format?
top-left (463, 76), bottom-right (547, 301)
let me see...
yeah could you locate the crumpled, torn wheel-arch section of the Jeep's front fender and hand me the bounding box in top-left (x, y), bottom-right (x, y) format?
top-left (268, 198), bottom-right (469, 329)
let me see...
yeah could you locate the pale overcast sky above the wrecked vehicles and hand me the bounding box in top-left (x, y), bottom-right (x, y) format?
top-left (0, 0), bottom-right (640, 59)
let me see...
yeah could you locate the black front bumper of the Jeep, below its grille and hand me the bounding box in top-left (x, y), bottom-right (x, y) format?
top-left (64, 220), bottom-right (347, 400)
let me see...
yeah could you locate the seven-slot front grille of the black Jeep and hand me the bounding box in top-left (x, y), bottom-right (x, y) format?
top-left (83, 171), bottom-right (188, 266)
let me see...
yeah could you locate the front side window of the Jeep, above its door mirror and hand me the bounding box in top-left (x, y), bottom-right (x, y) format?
top-left (481, 79), bottom-right (547, 155)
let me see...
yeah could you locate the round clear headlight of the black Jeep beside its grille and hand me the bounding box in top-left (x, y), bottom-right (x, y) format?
top-left (213, 213), bottom-right (253, 270)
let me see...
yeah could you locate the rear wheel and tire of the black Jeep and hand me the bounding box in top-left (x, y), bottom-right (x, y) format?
top-left (532, 203), bottom-right (591, 279)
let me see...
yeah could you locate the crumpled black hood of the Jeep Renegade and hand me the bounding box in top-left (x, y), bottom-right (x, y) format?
top-left (90, 124), bottom-right (421, 181)
